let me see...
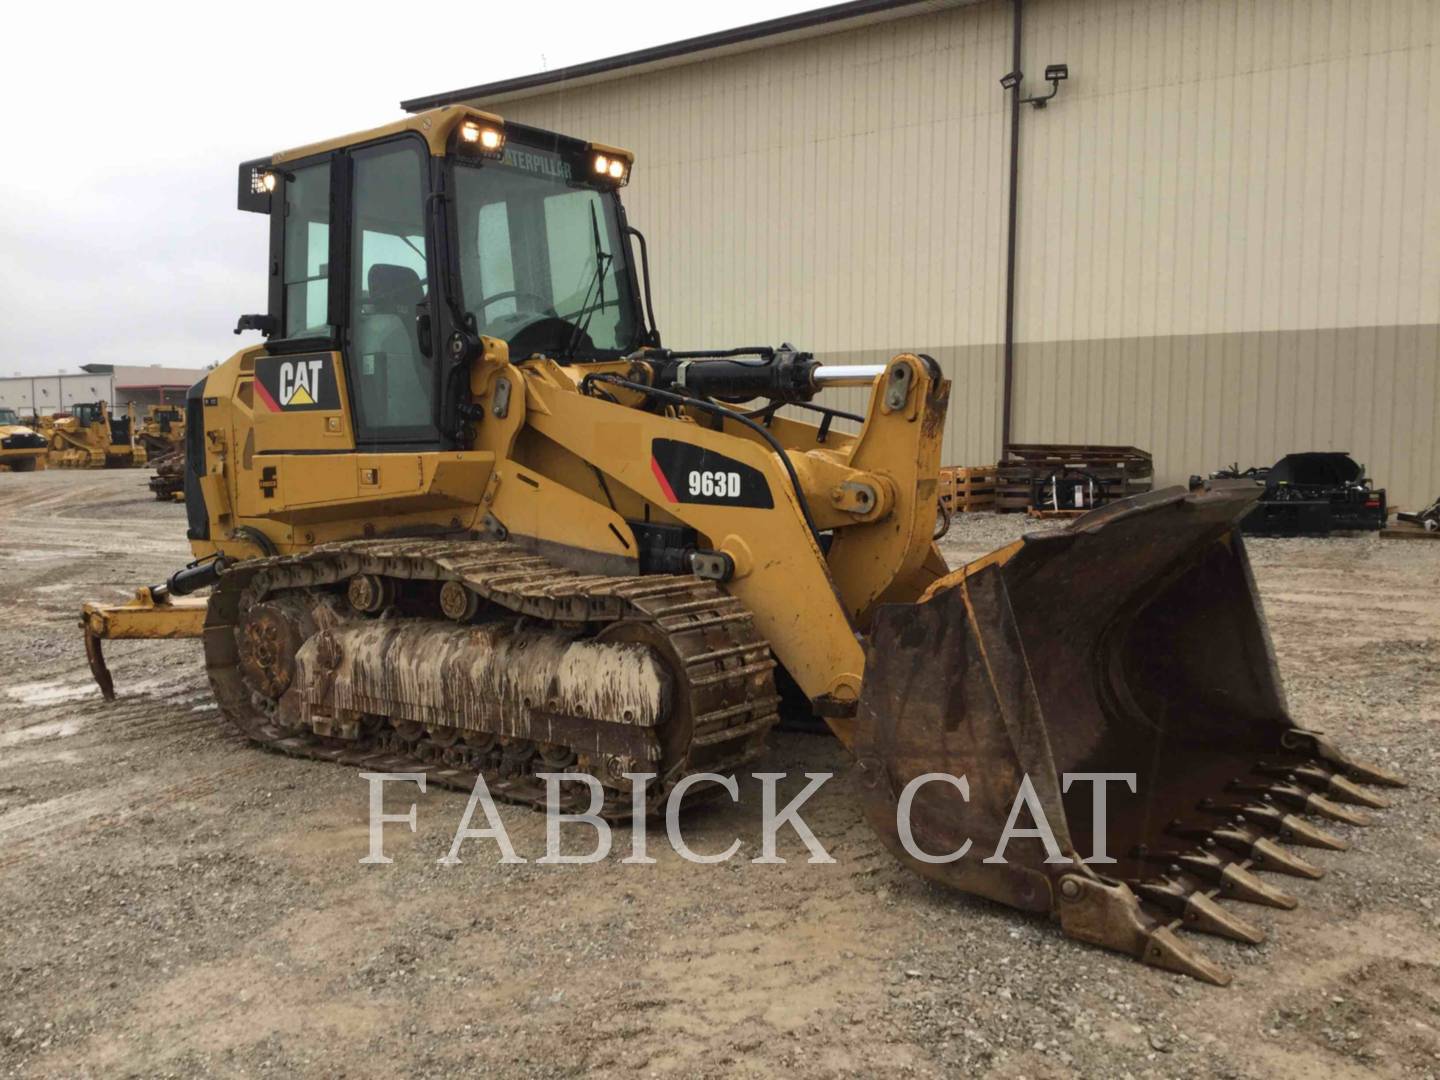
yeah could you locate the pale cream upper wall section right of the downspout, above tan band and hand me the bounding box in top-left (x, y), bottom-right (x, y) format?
top-left (1019, 0), bottom-right (1440, 341)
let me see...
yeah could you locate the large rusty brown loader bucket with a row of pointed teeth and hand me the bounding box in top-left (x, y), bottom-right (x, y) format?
top-left (854, 481), bottom-right (1400, 984)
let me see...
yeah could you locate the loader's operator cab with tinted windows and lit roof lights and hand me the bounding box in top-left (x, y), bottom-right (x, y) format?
top-left (239, 107), bottom-right (654, 451)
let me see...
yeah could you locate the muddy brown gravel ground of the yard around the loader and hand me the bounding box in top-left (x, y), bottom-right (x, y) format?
top-left (0, 469), bottom-right (1440, 1080)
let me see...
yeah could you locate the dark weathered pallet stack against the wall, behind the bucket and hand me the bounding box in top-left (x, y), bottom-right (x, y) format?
top-left (995, 442), bottom-right (1155, 513)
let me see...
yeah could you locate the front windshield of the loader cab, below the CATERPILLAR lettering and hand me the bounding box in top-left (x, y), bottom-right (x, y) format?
top-left (455, 144), bottom-right (641, 360)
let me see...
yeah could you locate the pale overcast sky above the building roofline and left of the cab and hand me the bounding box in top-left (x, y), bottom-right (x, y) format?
top-left (0, 0), bottom-right (824, 376)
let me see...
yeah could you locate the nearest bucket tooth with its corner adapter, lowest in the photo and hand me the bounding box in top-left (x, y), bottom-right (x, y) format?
top-left (1058, 874), bottom-right (1230, 986)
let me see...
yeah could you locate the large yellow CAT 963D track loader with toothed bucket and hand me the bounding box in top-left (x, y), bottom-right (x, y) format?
top-left (75, 107), bottom-right (1397, 984)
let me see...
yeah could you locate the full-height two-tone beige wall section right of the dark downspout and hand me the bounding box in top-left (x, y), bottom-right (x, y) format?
top-left (1015, 0), bottom-right (1440, 505)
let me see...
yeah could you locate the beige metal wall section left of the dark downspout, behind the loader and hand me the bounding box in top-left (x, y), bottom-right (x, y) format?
top-left (483, 3), bottom-right (1009, 462)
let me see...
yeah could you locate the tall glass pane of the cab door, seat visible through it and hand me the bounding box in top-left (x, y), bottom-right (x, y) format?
top-left (347, 140), bottom-right (438, 442)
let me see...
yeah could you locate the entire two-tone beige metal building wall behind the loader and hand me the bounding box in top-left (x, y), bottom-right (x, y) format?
top-left (481, 0), bottom-right (1440, 504)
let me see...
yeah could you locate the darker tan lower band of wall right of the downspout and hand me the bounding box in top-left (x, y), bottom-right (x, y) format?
top-left (1008, 325), bottom-right (1440, 507)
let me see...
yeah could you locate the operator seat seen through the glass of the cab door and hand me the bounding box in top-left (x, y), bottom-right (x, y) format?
top-left (354, 262), bottom-right (432, 428)
